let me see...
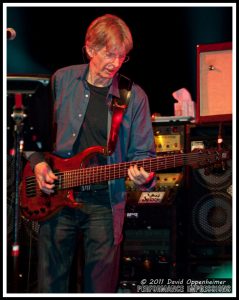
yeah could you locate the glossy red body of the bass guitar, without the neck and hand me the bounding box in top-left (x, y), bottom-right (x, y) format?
top-left (20, 146), bottom-right (105, 221)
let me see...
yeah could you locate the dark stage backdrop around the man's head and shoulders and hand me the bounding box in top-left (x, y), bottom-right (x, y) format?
top-left (7, 6), bottom-right (232, 115)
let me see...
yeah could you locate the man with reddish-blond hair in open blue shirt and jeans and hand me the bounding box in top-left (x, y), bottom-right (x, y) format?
top-left (23, 14), bottom-right (156, 293)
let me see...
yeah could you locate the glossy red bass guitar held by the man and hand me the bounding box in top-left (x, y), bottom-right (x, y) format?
top-left (19, 146), bottom-right (231, 221)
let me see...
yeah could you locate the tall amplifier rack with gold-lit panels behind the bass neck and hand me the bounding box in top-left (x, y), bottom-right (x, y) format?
top-left (120, 122), bottom-right (185, 282)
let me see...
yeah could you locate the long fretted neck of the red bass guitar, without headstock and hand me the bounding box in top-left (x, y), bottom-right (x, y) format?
top-left (57, 152), bottom-right (215, 189)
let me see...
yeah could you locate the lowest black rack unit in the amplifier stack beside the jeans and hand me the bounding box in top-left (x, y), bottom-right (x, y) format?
top-left (120, 229), bottom-right (174, 282)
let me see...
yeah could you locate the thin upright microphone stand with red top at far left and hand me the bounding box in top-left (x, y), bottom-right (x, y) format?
top-left (11, 94), bottom-right (26, 292)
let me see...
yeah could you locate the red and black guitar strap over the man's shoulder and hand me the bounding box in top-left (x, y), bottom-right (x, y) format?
top-left (107, 74), bottom-right (133, 155)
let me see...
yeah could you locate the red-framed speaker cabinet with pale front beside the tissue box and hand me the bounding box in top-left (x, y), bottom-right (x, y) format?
top-left (196, 42), bottom-right (232, 123)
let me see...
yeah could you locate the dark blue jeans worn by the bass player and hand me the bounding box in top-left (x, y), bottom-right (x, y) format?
top-left (38, 203), bottom-right (120, 293)
